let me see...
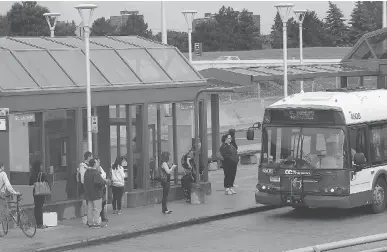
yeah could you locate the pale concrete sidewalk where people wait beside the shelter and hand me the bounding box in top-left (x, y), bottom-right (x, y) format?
top-left (0, 165), bottom-right (272, 252)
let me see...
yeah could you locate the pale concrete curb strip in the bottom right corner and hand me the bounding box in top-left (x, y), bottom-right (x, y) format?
top-left (285, 233), bottom-right (387, 252)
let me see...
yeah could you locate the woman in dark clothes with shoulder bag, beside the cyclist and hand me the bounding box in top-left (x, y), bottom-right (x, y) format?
top-left (30, 161), bottom-right (48, 229)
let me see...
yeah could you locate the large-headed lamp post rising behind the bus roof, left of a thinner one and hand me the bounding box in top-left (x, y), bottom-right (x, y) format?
top-left (275, 4), bottom-right (294, 97)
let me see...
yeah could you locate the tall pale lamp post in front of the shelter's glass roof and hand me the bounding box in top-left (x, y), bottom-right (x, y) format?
top-left (75, 4), bottom-right (97, 151)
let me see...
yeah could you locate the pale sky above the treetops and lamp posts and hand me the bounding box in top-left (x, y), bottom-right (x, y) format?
top-left (0, 0), bottom-right (354, 34)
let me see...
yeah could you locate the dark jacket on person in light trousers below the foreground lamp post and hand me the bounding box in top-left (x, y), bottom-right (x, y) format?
top-left (83, 168), bottom-right (105, 201)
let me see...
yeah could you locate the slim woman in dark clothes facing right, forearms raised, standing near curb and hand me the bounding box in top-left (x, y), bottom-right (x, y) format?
top-left (160, 151), bottom-right (176, 214)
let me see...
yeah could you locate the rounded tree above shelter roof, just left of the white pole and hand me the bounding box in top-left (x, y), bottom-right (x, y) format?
top-left (120, 15), bottom-right (152, 38)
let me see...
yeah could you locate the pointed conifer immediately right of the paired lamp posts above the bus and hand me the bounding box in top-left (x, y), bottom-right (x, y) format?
top-left (324, 1), bottom-right (348, 47)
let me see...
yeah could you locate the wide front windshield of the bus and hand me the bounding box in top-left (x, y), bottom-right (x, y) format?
top-left (261, 126), bottom-right (346, 169)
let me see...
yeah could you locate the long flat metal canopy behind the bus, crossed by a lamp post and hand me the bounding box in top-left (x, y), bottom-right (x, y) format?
top-left (200, 64), bottom-right (379, 85)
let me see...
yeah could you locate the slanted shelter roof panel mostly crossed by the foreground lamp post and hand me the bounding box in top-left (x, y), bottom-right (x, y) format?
top-left (51, 49), bottom-right (108, 86)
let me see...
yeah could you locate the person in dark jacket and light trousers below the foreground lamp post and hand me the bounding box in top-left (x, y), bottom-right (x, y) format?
top-left (83, 159), bottom-right (105, 228)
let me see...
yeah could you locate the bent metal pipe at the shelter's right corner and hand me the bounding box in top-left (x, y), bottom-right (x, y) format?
top-left (194, 86), bottom-right (253, 183)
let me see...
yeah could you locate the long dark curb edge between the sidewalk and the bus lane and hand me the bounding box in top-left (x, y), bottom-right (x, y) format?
top-left (30, 206), bottom-right (280, 252)
